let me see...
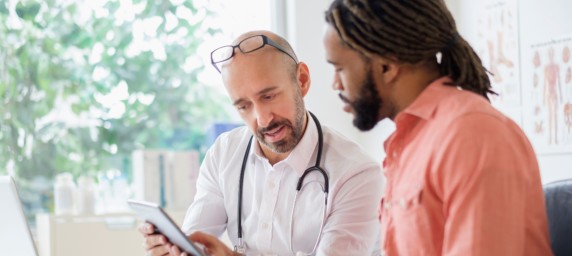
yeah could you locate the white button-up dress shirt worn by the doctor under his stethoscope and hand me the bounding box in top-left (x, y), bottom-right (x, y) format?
top-left (182, 114), bottom-right (382, 255)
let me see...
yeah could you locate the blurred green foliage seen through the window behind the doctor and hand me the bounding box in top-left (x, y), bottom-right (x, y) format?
top-left (0, 0), bottom-right (232, 183)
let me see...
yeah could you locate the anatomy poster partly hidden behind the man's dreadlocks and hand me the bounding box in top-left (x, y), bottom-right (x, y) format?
top-left (474, 0), bottom-right (521, 112)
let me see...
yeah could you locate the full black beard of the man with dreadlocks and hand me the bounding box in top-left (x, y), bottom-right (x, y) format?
top-left (339, 70), bottom-right (382, 131)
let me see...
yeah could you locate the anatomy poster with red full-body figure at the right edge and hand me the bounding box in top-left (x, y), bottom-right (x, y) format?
top-left (522, 34), bottom-right (572, 153)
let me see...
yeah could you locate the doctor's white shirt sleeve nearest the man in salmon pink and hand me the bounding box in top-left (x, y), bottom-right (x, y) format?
top-left (317, 165), bottom-right (382, 255)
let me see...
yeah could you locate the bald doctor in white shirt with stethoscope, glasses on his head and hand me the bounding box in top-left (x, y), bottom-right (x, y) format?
top-left (140, 31), bottom-right (382, 255)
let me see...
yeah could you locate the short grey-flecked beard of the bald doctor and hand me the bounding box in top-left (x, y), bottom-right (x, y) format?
top-left (256, 91), bottom-right (306, 154)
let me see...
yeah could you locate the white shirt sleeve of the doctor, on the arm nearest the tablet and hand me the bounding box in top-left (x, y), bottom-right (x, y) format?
top-left (182, 143), bottom-right (228, 237)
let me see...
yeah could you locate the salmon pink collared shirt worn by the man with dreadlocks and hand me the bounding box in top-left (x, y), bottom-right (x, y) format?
top-left (380, 77), bottom-right (552, 256)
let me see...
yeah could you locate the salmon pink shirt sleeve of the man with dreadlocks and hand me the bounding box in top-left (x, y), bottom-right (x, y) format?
top-left (431, 114), bottom-right (539, 255)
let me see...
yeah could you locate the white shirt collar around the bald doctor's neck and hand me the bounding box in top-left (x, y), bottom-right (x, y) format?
top-left (253, 113), bottom-right (318, 176)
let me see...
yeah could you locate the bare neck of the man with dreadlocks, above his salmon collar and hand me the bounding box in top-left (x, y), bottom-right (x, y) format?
top-left (391, 63), bottom-right (441, 121)
